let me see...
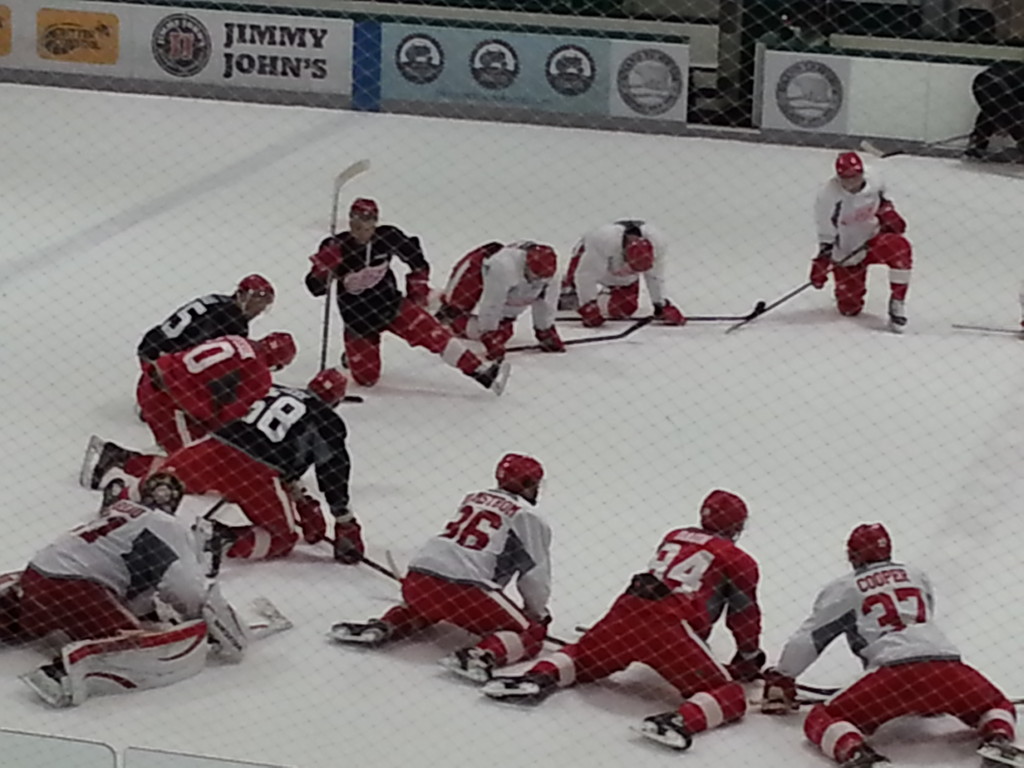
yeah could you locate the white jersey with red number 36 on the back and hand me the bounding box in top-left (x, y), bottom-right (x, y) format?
top-left (409, 490), bottom-right (551, 618)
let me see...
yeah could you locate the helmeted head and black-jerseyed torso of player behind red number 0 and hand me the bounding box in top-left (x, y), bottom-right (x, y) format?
top-left (138, 274), bottom-right (273, 369)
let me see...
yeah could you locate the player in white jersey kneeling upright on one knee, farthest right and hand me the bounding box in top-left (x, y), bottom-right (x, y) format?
top-left (810, 152), bottom-right (912, 333)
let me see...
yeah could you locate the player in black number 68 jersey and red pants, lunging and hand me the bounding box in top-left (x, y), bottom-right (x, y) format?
top-left (90, 369), bottom-right (364, 563)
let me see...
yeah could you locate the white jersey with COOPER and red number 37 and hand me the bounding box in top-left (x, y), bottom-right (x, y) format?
top-left (776, 562), bottom-right (959, 677)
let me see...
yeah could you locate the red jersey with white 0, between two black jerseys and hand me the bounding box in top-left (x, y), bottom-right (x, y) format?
top-left (154, 336), bottom-right (271, 429)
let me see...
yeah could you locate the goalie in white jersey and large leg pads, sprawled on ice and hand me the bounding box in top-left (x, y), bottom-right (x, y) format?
top-left (0, 474), bottom-right (287, 707)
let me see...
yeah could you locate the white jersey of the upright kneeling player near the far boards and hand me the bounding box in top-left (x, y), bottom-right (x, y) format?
top-left (814, 171), bottom-right (887, 266)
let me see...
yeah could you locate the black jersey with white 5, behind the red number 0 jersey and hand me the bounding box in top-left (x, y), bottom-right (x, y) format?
top-left (138, 294), bottom-right (249, 362)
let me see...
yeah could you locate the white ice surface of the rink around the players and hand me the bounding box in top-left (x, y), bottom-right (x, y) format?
top-left (0, 86), bottom-right (1024, 768)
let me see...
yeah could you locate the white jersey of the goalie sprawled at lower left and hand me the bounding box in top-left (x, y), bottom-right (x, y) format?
top-left (29, 500), bottom-right (206, 618)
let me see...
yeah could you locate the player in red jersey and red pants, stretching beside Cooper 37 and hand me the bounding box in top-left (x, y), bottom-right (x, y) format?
top-left (483, 490), bottom-right (765, 750)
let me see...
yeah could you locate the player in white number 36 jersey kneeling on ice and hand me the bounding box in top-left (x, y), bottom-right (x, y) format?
top-left (331, 454), bottom-right (551, 683)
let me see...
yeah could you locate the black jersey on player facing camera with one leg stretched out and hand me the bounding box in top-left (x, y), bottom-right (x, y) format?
top-left (306, 224), bottom-right (429, 336)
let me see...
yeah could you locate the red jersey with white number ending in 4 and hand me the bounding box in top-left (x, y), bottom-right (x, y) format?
top-left (647, 528), bottom-right (761, 651)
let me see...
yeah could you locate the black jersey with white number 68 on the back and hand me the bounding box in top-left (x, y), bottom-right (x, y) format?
top-left (213, 384), bottom-right (351, 516)
